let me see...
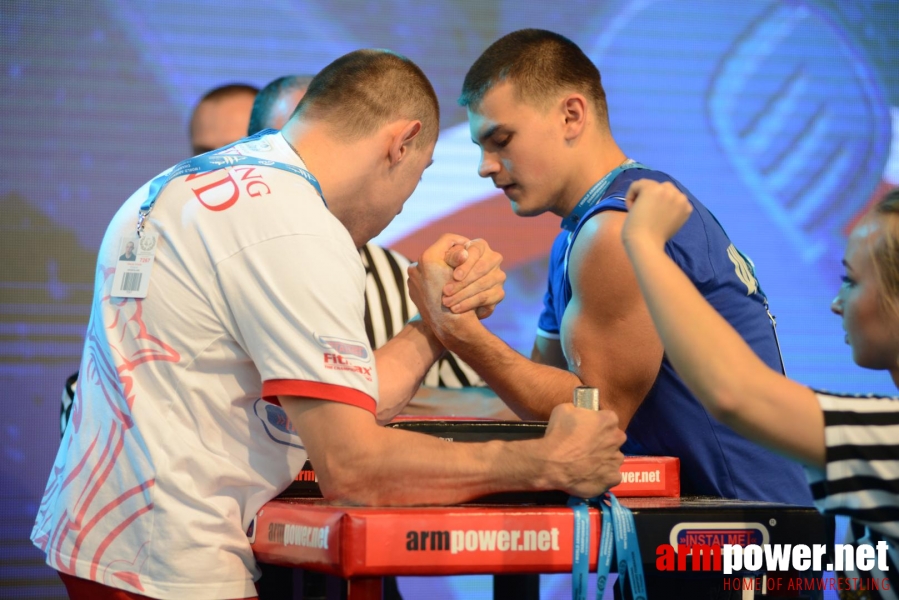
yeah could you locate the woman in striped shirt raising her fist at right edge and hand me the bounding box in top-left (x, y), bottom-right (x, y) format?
top-left (622, 180), bottom-right (899, 598)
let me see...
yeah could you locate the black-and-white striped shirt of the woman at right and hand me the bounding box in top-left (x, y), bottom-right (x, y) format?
top-left (806, 392), bottom-right (899, 600)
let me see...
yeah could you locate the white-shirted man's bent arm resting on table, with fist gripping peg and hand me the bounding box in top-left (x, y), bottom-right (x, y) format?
top-left (280, 396), bottom-right (624, 505)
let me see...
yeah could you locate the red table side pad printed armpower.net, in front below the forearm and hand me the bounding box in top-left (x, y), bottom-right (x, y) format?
top-left (251, 499), bottom-right (600, 578)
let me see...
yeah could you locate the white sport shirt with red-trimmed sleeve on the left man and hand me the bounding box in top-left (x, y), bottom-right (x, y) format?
top-left (32, 133), bottom-right (378, 599)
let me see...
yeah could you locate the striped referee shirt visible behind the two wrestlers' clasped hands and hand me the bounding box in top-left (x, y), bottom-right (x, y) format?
top-left (359, 244), bottom-right (485, 388)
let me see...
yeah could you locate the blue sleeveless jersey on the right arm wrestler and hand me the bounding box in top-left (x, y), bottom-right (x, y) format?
top-left (539, 169), bottom-right (812, 506)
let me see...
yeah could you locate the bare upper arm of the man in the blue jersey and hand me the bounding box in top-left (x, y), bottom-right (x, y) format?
top-left (561, 212), bottom-right (664, 429)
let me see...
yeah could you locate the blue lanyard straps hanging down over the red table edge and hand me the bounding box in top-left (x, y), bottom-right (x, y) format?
top-left (568, 493), bottom-right (646, 600)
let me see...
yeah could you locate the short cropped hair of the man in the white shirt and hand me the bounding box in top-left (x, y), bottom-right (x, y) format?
top-left (294, 50), bottom-right (440, 144)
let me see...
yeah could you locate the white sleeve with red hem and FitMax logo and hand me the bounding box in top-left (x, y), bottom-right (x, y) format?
top-left (216, 232), bottom-right (378, 412)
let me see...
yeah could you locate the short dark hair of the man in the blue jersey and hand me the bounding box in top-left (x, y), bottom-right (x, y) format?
top-left (459, 29), bottom-right (609, 127)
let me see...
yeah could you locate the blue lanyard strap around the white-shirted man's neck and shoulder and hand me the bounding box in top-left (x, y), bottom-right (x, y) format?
top-left (137, 129), bottom-right (328, 237)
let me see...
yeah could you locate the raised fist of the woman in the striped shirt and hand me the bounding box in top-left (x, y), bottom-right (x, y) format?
top-left (621, 179), bottom-right (693, 246)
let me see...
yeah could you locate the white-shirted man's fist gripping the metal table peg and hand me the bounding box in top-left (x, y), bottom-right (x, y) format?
top-left (544, 404), bottom-right (627, 498)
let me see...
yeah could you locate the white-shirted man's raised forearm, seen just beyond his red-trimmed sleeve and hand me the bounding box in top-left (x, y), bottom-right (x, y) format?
top-left (375, 319), bottom-right (444, 423)
